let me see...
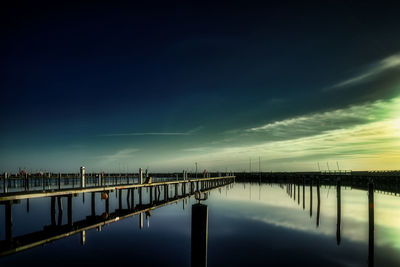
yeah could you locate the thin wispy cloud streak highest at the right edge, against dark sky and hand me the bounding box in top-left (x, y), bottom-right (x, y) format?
top-left (324, 54), bottom-right (400, 91)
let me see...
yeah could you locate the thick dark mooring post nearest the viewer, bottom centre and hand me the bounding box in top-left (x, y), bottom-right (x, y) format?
top-left (191, 203), bottom-right (208, 267)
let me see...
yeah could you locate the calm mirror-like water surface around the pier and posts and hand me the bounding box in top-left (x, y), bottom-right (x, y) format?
top-left (0, 183), bottom-right (400, 266)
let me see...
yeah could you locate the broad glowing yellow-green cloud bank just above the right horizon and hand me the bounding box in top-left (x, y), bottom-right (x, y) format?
top-left (155, 98), bottom-right (400, 171)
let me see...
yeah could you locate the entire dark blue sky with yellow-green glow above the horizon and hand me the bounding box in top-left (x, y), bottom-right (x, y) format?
top-left (0, 1), bottom-right (400, 172)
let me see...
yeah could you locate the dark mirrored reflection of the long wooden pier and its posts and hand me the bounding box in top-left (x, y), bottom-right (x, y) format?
top-left (0, 177), bottom-right (234, 256)
